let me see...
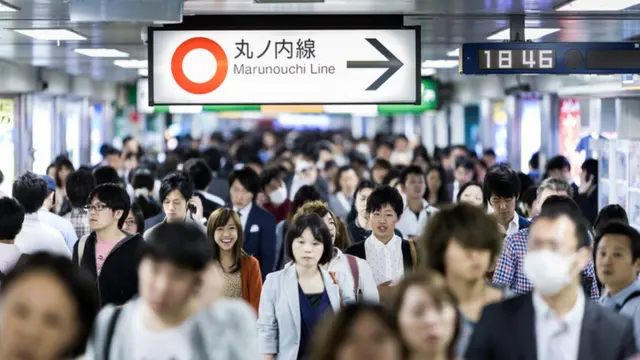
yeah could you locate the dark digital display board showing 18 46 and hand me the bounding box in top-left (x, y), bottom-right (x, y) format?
top-left (460, 42), bottom-right (640, 75)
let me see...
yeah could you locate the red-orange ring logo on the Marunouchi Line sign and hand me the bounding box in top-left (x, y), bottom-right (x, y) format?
top-left (171, 37), bottom-right (229, 95)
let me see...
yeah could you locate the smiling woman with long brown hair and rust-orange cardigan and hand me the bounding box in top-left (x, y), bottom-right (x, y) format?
top-left (207, 208), bottom-right (262, 311)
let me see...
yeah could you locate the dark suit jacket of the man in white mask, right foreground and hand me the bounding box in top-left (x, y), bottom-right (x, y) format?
top-left (465, 293), bottom-right (637, 360)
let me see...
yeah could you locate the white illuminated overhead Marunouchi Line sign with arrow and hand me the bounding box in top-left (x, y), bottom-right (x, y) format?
top-left (149, 27), bottom-right (422, 105)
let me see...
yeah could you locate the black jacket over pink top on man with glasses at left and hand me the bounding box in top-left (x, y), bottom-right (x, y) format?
top-left (73, 232), bottom-right (144, 306)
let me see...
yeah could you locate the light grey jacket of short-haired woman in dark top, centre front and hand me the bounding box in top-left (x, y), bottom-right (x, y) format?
top-left (258, 266), bottom-right (355, 360)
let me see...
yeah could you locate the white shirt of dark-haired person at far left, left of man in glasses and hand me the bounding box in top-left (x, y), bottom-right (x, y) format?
top-left (15, 212), bottom-right (71, 258)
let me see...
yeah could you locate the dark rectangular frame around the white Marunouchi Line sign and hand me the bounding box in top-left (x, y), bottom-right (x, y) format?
top-left (147, 25), bottom-right (422, 106)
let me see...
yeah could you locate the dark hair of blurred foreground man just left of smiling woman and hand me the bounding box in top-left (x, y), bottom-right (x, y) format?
top-left (140, 221), bottom-right (214, 271)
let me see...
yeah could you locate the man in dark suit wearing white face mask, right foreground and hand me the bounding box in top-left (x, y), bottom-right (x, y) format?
top-left (465, 196), bottom-right (636, 360)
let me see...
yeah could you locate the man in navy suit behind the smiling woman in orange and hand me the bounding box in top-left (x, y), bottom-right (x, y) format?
top-left (229, 167), bottom-right (276, 279)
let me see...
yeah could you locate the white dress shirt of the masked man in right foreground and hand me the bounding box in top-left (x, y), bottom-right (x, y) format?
top-left (533, 290), bottom-right (585, 360)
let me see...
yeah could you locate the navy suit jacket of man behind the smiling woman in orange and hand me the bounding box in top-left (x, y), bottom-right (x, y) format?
top-left (243, 204), bottom-right (276, 280)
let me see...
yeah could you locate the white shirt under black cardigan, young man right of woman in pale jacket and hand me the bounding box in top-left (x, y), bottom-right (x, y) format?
top-left (364, 234), bottom-right (404, 286)
